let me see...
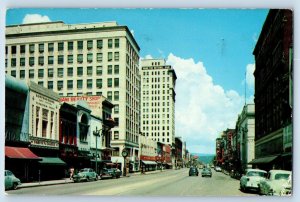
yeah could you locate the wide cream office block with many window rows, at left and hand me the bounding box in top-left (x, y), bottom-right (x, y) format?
top-left (5, 21), bottom-right (140, 169)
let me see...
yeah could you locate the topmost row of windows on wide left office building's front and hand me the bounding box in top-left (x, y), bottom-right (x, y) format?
top-left (5, 39), bottom-right (120, 54)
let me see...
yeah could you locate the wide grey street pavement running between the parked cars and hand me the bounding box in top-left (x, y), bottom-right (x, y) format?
top-left (7, 168), bottom-right (257, 197)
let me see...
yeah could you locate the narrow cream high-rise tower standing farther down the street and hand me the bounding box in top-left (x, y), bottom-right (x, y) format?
top-left (141, 59), bottom-right (177, 145)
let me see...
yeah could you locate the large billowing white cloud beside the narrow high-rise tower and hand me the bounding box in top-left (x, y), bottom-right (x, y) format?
top-left (167, 53), bottom-right (244, 153)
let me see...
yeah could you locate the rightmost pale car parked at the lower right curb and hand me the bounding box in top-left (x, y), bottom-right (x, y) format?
top-left (258, 170), bottom-right (292, 196)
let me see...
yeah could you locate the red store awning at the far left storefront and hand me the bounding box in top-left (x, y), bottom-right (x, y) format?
top-left (5, 146), bottom-right (41, 160)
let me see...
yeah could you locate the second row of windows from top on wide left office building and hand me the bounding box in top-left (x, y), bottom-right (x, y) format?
top-left (5, 52), bottom-right (120, 67)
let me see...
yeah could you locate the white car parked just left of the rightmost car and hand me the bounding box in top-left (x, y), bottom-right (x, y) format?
top-left (240, 169), bottom-right (267, 191)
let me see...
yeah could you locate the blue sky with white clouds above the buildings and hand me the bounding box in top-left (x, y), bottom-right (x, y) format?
top-left (6, 8), bottom-right (268, 154)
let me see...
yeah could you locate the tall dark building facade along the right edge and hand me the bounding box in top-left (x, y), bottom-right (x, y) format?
top-left (252, 9), bottom-right (293, 170)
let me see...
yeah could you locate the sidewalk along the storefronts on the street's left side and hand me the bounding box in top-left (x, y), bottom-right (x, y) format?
top-left (18, 170), bottom-right (166, 188)
